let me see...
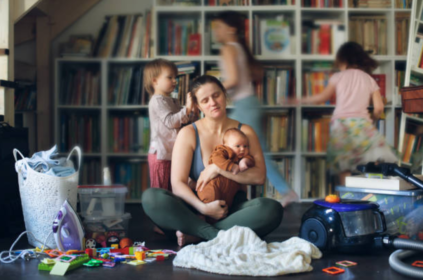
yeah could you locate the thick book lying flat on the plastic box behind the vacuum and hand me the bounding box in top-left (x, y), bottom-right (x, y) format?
top-left (345, 175), bottom-right (423, 191)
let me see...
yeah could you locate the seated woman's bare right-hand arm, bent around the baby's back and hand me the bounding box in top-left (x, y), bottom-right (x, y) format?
top-left (196, 125), bottom-right (266, 190)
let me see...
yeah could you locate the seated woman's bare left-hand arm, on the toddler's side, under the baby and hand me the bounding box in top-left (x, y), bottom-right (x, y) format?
top-left (171, 126), bottom-right (228, 220)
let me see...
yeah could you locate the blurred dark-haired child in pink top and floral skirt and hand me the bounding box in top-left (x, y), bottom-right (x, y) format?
top-left (300, 42), bottom-right (398, 185)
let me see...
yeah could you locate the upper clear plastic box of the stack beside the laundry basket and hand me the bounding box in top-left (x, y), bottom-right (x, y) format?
top-left (78, 185), bottom-right (128, 218)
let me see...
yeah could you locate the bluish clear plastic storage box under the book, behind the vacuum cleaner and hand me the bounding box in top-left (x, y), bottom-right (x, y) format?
top-left (336, 187), bottom-right (423, 240)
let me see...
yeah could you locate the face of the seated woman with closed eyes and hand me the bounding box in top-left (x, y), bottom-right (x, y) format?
top-left (195, 83), bottom-right (226, 119)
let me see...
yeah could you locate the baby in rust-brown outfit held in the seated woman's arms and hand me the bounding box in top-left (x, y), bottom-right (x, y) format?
top-left (197, 128), bottom-right (255, 212)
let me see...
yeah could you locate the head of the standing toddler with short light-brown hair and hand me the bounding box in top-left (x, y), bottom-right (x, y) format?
top-left (143, 58), bottom-right (178, 95)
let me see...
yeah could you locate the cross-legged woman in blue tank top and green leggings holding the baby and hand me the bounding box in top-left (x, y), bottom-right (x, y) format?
top-left (142, 75), bottom-right (283, 246)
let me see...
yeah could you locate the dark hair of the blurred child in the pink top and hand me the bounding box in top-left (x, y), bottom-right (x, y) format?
top-left (335, 42), bottom-right (378, 74)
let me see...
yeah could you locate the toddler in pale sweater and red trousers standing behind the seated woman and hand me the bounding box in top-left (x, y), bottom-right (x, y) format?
top-left (144, 59), bottom-right (196, 191)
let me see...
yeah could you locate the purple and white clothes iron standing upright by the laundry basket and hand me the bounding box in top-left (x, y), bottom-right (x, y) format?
top-left (53, 200), bottom-right (84, 252)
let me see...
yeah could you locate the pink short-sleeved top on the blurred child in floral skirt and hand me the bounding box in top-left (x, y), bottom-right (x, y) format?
top-left (329, 69), bottom-right (379, 120)
